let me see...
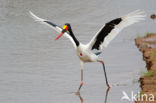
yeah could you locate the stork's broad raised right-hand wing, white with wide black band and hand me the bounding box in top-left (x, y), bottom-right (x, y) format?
top-left (88, 10), bottom-right (145, 50)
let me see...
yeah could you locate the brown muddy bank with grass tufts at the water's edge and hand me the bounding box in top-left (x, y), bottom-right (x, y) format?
top-left (135, 33), bottom-right (156, 103)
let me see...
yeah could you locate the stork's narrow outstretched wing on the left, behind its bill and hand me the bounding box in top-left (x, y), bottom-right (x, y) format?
top-left (29, 11), bottom-right (76, 47)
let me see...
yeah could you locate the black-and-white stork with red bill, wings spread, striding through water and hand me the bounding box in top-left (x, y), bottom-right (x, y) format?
top-left (30, 10), bottom-right (145, 92)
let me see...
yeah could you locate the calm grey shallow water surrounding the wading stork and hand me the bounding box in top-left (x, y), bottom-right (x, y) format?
top-left (0, 0), bottom-right (156, 103)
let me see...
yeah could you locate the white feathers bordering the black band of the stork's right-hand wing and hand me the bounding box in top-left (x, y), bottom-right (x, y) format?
top-left (87, 10), bottom-right (146, 49)
